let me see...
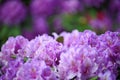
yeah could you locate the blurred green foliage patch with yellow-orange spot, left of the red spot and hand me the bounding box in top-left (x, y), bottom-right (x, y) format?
top-left (62, 15), bottom-right (91, 31)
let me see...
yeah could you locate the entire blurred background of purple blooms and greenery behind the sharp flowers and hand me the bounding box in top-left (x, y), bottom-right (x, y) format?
top-left (0, 0), bottom-right (120, 47)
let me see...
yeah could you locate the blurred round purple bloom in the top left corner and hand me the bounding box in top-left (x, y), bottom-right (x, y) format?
top-left (0, 1), bottom-right (26, 25)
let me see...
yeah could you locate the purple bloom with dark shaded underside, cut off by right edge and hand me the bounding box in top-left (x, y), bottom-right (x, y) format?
top-left (100, 32), bottom-right (120, 65)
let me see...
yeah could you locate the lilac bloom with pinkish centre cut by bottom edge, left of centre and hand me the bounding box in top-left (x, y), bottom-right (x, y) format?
top-left (14, 60), bottom-right (46, 80)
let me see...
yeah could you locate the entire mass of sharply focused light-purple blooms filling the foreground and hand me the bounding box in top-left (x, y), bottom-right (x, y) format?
top-left (0, 30), bottom-right (120, 80)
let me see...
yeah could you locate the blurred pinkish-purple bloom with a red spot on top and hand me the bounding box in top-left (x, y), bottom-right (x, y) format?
top-left (89, 12), bottom-right (112, 31)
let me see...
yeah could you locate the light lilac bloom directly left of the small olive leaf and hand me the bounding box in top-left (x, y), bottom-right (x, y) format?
top-left (21, 35), bottom-right (62, 66)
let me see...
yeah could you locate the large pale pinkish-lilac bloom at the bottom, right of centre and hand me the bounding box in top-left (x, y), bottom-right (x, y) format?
top-left (58, 45), bottom-right (98, 80)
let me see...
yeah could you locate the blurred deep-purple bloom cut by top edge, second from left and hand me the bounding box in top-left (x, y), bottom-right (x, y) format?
top-left (30, 0), bottom-right (56, 18)
